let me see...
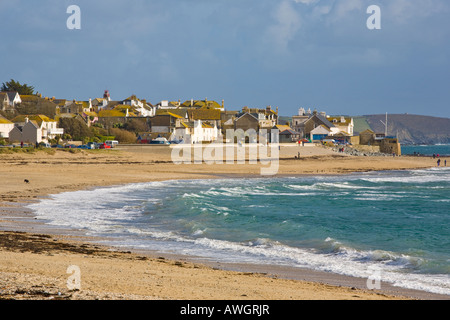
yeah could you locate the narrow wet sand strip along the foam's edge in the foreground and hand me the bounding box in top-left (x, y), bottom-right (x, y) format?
top-left (0, 182), bottom-right (450, 300)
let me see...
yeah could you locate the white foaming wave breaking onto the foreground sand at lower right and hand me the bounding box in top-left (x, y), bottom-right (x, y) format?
top-left (187, 238), bottom-right (450, 295)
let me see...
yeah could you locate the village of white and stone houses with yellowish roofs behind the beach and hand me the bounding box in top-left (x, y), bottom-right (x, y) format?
top-left (0, 90), bottom-right (401, 155)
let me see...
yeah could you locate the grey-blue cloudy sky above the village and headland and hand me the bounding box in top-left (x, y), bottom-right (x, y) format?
top-left (0, 0), bottom-right (450, 118)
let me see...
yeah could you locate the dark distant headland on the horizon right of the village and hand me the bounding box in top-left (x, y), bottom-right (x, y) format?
top-left (355, 114), bottom-right (450, 144)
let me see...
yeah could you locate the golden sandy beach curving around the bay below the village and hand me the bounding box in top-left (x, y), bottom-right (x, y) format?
top-left (0, 146), bottom-right (449, 300)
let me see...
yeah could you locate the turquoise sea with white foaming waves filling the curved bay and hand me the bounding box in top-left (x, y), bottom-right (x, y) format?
top-left (29, 167), bottom-right (450, 295)
